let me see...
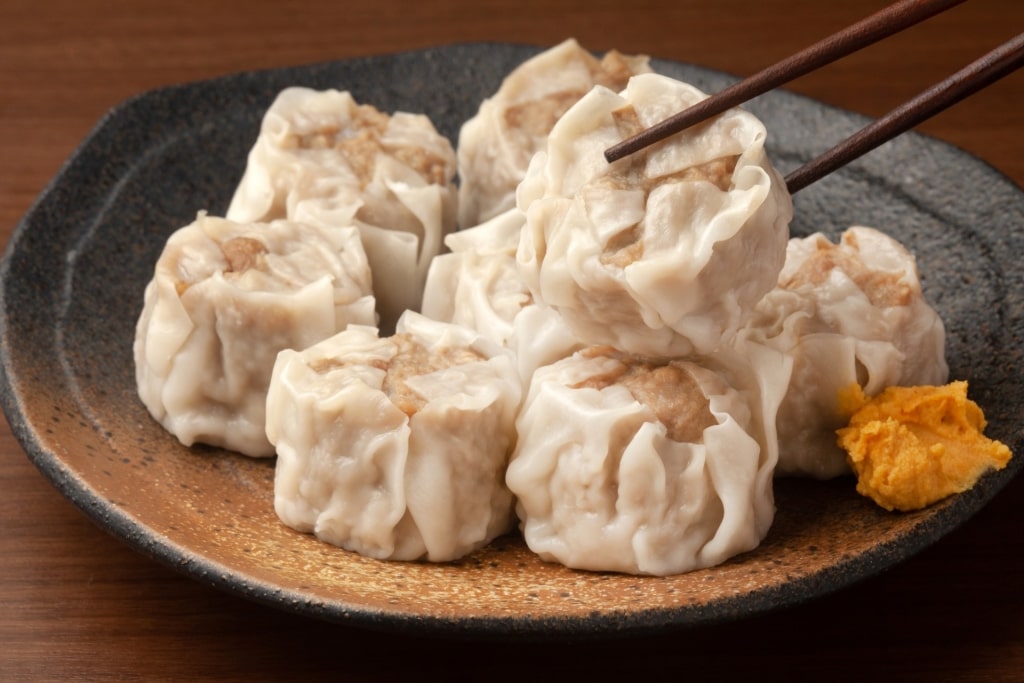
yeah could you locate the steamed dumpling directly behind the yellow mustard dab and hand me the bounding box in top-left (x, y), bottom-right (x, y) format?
top-left (742, 226), bottom-right (949, 479)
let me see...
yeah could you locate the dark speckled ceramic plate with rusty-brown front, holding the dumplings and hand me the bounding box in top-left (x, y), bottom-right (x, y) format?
top-left (0, 45), bottom-right (1024, 637)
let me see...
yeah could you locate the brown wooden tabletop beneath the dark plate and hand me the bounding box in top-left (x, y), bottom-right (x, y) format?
top-left (0, 0), bottom-right (1024, 681)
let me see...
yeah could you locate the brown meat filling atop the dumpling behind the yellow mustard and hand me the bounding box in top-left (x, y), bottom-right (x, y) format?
top-left (779, 237), bottom-right (913, 308)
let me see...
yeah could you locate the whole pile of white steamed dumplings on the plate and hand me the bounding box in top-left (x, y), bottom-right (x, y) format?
top-left (134, 40), bottom-right (948, 575)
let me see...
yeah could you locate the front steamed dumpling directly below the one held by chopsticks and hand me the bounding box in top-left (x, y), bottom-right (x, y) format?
top-left (507, 345), bottom-right (791, 575)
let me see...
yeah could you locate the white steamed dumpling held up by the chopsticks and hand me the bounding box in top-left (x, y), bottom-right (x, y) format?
top-left (517, 74), bottom-right (793, 357)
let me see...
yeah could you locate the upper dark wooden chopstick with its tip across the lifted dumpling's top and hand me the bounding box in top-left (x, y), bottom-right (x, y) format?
top-left (604, 0), bottom-right (965, 163)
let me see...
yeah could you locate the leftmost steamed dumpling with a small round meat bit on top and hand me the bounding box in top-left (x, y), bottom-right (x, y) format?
top-left (134, 213), bottom-right (376, 457)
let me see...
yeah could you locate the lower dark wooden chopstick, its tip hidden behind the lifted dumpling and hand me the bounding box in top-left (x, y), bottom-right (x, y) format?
top-left (785, 33), bottom-right (1024, 195)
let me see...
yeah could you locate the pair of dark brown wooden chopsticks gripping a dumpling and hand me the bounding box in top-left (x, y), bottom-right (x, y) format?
top-left (604, 0), bottom-right (1024, 194)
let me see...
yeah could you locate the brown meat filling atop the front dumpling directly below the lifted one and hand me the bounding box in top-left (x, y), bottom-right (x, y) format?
top-left (572, 349), bottom-right (718, 443)
